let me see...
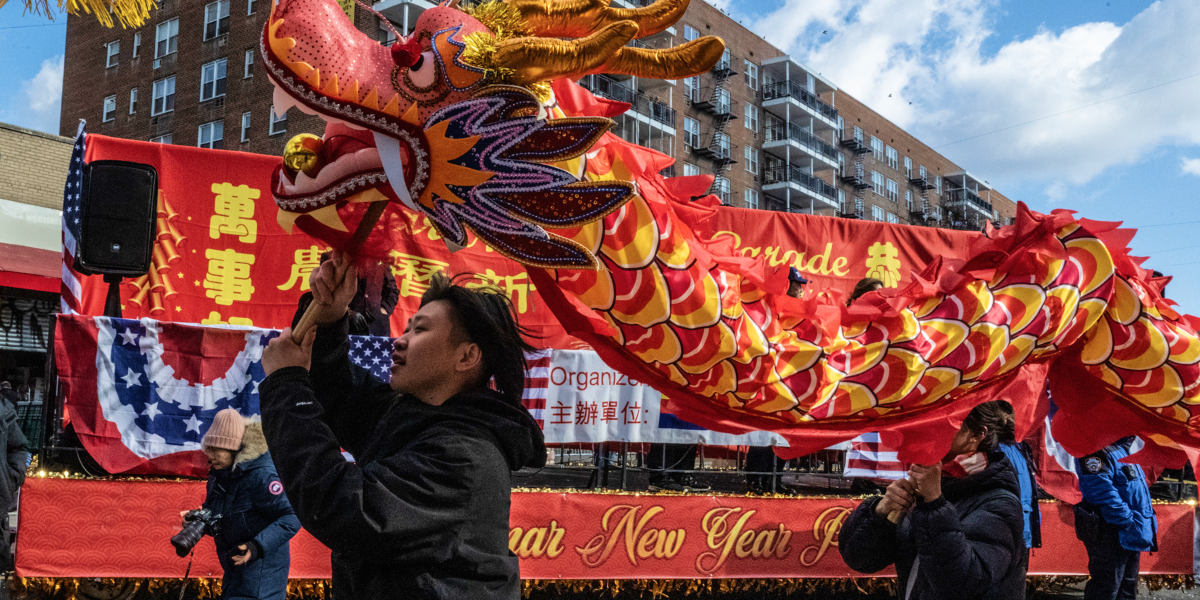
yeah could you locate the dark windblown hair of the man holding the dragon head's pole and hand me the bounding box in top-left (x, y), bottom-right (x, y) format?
top-left (421, 274), bottom-right (536, 406)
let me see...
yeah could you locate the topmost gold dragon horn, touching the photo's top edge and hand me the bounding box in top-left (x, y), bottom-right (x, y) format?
top-left (509, 0), bottom-right (690, 37)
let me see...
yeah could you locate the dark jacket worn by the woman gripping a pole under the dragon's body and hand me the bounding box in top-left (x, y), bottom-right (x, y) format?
top-left (838, 452), bottom-right (1026, 600)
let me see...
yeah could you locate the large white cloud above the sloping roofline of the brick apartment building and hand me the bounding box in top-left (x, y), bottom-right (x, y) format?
top-left (743, 0), bottom-right (1200, 193)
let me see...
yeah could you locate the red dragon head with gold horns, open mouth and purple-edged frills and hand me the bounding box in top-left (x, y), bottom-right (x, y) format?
top-left (262, 0), bottom-right (724, 268)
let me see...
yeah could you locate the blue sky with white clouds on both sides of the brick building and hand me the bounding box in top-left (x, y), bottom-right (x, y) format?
top-left (0, 0), bottom-right (1200, 314)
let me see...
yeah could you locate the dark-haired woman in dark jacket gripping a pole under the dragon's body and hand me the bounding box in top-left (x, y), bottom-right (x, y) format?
top-left (838, 401), bottom-right (1027, 600)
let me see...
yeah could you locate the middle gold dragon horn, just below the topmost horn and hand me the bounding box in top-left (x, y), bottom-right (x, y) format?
top-left (494, 20), bottom-right (637, 85)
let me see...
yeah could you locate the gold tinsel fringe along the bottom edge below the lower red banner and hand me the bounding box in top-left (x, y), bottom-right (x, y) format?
top-left (10, 575), bottom-right (1195, 600)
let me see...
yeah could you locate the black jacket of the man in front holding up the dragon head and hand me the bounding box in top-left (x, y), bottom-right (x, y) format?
top-left (260, 318), bottom-right (546, 600)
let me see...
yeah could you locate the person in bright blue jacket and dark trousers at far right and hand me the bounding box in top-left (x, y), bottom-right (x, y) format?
top-left (1075, 437), bottom-right (1158, 600)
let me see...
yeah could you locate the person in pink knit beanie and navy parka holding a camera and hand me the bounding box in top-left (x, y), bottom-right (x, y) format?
top-left (195, 408), bottom-right (300, 600)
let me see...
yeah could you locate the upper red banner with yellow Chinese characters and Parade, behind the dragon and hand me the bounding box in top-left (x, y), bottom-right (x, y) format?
top-left (82, 134), bottom-right (979, 348)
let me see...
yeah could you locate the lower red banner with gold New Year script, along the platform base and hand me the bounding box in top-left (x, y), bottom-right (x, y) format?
top-left (17, 478), bottom-right (1194, 580)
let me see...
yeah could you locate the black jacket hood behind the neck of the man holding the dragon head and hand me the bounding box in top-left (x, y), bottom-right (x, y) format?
top-left (406, 389), bottom-right (546, 470)
